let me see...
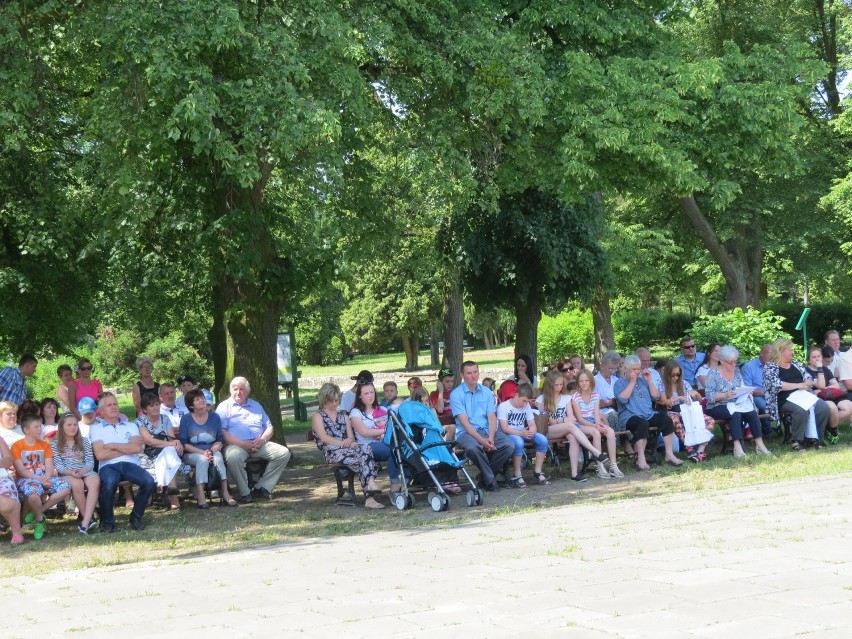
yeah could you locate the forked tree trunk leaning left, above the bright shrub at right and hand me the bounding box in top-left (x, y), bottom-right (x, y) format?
top-left (678, 196), bottom-right (763, 309)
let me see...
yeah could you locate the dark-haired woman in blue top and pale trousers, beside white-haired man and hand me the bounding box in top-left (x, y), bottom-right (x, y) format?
top-left (178, 388), bottom-right (237, 510)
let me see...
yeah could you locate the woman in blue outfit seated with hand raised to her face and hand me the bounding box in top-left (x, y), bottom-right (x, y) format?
top-left (613, 355), bottom-right (683, 470)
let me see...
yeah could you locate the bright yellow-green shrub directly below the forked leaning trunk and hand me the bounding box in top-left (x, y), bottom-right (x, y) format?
top-left (689, 307), bottom-right (790, 361)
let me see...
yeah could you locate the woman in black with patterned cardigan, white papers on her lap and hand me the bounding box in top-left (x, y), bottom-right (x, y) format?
top-left (763, 339), bottom-right (829, 452)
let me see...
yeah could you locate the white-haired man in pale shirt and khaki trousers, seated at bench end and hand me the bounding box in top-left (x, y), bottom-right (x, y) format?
top-left (216, 377), bottom-right (290, 504)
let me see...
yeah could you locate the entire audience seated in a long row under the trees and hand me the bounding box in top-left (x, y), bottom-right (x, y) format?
top-left (0, 331), bottom-right (852, 544)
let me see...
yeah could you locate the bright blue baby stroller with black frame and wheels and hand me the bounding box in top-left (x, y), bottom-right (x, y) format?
top-left (384, 401), bottom-right (483, 513)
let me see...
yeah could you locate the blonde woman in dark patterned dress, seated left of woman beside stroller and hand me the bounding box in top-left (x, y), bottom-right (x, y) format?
top-left (311, 383), bottom-right (384, 510)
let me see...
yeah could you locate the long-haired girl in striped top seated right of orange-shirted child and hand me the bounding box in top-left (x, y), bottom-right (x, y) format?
top-left (50, 413), bottom-right (101, 535)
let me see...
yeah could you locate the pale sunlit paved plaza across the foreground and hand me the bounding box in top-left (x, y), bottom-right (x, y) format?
top-left (6, 473), bottom-right (852, 639)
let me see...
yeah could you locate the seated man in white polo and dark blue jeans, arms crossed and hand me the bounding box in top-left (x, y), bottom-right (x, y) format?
top-left (89, 393), bottom-right (157, 533)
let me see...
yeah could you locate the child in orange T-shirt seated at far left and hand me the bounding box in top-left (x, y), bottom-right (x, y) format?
top-left (12, 414), bottom-right (71, 539)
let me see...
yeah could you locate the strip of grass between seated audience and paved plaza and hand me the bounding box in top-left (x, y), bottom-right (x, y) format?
top-left (0, 420), bottom-right (852, 577)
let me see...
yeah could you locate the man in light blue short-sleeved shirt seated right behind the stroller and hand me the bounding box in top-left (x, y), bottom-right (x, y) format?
top-left (450, 361), bottom-right (514, 491)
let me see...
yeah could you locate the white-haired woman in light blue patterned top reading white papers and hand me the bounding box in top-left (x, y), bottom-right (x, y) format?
top-left (704, 345), bottom-right (772, 458)
